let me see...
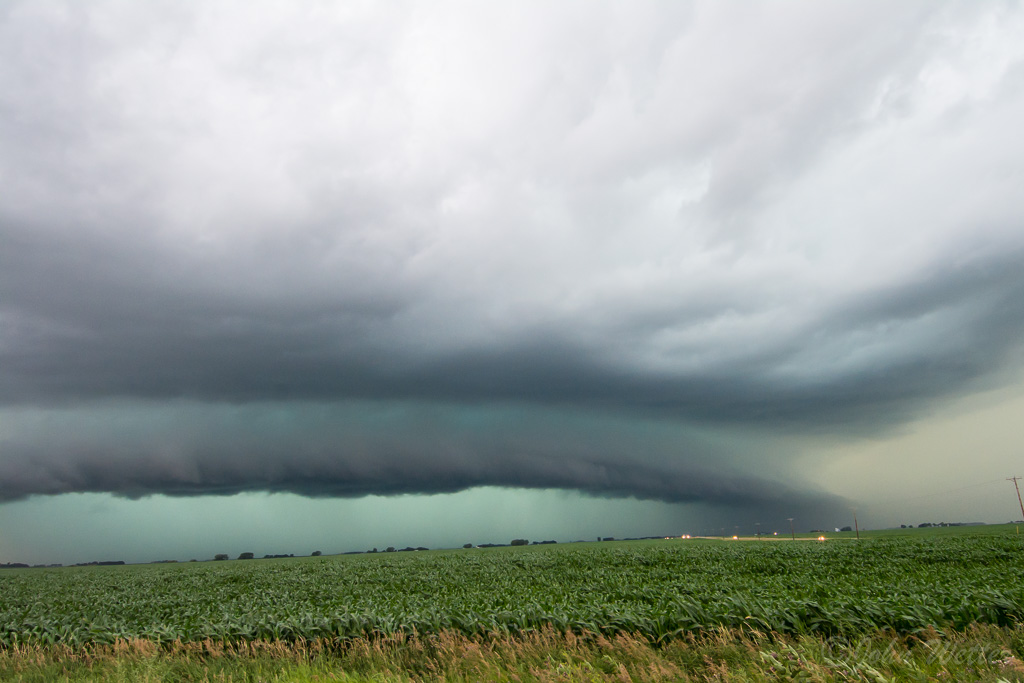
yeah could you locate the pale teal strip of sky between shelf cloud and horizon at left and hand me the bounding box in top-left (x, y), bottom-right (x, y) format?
top-left (0, 488), bottom-right (685, 563)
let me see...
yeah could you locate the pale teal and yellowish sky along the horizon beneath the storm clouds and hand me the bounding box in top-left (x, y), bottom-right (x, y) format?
top-left (0, 374), bottom-right (1024, 564)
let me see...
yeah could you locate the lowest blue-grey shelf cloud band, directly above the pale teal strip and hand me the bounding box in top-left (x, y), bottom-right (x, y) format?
top-left (0, 401), bottom-right (841, 520)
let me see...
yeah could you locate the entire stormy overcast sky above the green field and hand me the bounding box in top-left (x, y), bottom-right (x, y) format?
top-left (0, 0), bottom-right (1024, 562)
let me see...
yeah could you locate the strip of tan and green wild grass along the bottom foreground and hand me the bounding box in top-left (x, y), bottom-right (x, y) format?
top-left (0, 625), bottom-right (1024, 683)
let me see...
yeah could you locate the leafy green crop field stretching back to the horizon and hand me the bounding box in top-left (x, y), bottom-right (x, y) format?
top-left (0, 527), bottom-right (1024, 680)
